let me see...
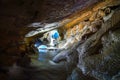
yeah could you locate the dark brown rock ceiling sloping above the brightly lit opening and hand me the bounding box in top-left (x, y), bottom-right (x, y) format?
top-left (0, 0), bottom-right (101, 55)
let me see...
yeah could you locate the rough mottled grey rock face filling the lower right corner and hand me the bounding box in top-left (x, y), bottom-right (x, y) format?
top-left (77, 8), bottom-right (120, 80)
